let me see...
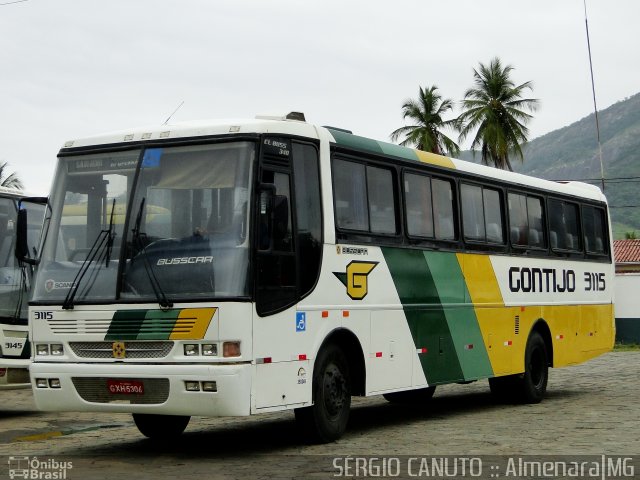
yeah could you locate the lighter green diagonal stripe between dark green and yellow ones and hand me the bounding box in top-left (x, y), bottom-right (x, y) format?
top-left (424, 251), bottom-right (493, 380)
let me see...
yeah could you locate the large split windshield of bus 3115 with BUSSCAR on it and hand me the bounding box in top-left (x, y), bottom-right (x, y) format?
top-left (33, 142), bottom-right (255, 308)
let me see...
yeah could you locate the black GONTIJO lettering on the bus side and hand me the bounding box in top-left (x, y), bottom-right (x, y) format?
top-left (509, 267), bottom-right (576, 293)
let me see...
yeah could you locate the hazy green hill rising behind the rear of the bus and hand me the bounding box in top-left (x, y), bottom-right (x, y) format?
top-left (462, 93), bottom-right (640, 237)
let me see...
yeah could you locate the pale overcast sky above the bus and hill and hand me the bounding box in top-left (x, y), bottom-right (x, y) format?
top-left (0, 0), bottom-right (640, 194)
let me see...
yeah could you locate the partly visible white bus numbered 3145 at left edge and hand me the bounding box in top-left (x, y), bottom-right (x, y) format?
top-left (0, 187), bottom-right (46, 389)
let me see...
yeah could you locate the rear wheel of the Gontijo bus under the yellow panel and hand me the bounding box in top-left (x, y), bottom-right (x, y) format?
top-left (518, 332), bottom-right (549, 403)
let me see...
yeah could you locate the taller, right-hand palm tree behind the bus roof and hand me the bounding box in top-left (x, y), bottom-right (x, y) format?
top-left (457, 58), bottom-right (538, 170)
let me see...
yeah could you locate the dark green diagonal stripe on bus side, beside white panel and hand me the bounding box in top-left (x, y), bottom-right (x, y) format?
top-left (382, 248), bottom-right (464, 384)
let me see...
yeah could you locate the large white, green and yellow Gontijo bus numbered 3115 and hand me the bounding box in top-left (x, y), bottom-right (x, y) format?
top-left (23, 115), bottom-right (614, 441)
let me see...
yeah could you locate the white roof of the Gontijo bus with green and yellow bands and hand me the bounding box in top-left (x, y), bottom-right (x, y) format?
top-left (58, 114), bottom-right (606, 202)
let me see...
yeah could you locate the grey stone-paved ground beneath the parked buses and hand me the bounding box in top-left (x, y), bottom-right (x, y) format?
top-left (0, 352), bottom-right (640, 480)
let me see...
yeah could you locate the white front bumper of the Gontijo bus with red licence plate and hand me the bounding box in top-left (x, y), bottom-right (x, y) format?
top-left (30, 363), bottom-right (251, 417)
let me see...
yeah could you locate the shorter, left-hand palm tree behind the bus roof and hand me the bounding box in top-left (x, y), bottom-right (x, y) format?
top-left (391, 85), bottom-right (460, 156)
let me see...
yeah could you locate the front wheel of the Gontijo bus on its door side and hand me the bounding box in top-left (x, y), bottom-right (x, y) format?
top-left (295, 344), bottom-right (351, 443)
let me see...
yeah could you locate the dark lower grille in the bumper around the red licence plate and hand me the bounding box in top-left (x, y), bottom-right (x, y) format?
top-left (71, 377), bottom-right (169, 405)
